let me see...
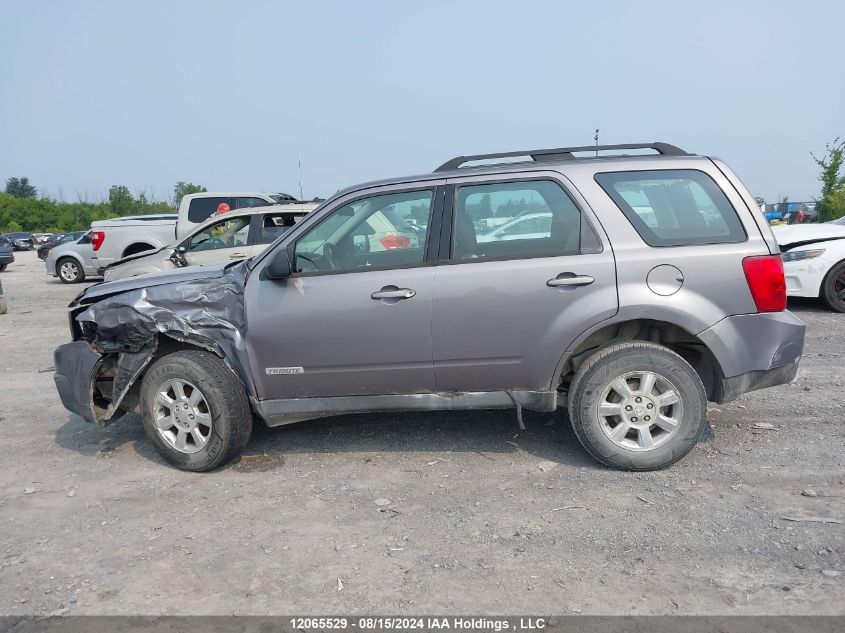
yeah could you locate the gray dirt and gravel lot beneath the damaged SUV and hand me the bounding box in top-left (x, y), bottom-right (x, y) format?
top-left (0, 253), bottom-right (845, 614)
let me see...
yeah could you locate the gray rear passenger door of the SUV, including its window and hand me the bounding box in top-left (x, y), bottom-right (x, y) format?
top-left (432, 172), bottom-right (618, 391)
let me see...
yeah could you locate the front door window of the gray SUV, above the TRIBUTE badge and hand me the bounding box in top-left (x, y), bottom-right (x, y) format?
top-left (294, 189), bottom-right (434, 273)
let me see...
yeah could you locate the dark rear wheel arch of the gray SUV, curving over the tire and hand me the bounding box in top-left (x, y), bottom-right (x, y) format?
top-left (551, 317), bottom-right (723, 401)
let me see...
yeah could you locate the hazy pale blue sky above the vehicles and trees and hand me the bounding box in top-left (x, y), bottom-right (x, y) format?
top-left (0, 0), bottom-right (845, 201)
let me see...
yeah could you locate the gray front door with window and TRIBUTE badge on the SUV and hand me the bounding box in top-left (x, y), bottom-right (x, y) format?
top-left (246, 187), bottom-right (436, 400)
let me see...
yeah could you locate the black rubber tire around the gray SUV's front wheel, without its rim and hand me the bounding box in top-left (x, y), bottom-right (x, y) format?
top-left (141, 350), bottom-right (252, 472)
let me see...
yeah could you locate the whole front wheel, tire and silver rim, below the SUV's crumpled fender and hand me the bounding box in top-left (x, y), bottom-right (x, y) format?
top-left (141, 350), bottom-right (252, 472)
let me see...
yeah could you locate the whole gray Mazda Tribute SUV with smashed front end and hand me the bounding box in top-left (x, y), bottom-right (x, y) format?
top-left (55, 143), bottom-right (804, 471)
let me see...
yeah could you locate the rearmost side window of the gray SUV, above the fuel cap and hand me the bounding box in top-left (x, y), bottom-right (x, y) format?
top-left (596, 169), bottom-right (746, 246)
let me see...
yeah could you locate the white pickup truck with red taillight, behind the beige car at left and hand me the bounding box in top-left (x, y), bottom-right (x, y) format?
top-left (91, 191), bottom-right (301, 270)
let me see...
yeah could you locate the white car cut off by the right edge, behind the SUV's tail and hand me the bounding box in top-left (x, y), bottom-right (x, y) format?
top-left (772, 218), bottom-right (845, 312)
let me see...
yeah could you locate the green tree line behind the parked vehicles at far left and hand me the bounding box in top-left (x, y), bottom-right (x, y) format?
top-left (0, 177), bottom-right (207, 233)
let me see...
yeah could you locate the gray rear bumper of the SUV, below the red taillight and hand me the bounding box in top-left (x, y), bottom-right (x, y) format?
top-left (699, 310), bottom-right (806, 402)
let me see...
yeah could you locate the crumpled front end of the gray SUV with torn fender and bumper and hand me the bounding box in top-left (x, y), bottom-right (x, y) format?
top-left (54, 262), bottom-right (249, 425)
